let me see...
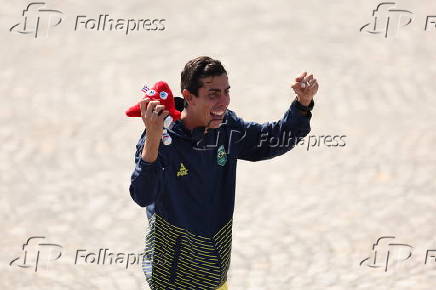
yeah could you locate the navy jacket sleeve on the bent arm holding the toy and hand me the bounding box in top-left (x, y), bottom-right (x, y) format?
top-left (129, 130), bottom-right (163, 207)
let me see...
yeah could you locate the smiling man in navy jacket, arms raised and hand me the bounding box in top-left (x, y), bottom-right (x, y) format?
top-left (130, 57), bottom-right (318, 289)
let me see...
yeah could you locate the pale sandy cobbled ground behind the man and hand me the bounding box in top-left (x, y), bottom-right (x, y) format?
top-left (0, 0), bottom-right (436, 290)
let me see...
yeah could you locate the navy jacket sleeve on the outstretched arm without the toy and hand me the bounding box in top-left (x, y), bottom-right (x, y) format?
top-left (236, 100), bottom-right (312, 161)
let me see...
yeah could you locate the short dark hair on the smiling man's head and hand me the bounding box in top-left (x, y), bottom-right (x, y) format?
top-left (180, 56), bottom-right (227, 107)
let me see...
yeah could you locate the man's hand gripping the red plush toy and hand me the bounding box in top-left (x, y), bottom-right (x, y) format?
top-left (140, 97), bottom-right (169, 140)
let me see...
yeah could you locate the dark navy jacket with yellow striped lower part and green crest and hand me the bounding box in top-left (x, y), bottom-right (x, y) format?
top-left (129, 101), bottom-right (311, 289)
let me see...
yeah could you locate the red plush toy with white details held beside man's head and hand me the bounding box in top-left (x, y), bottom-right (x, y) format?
top-left (126, 81), bottom-right (180, 145)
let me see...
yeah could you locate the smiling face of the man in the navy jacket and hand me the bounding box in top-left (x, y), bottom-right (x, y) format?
top-left (188, 74), bottom-right (230, 128)
